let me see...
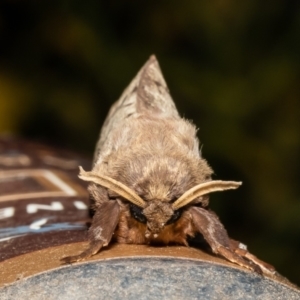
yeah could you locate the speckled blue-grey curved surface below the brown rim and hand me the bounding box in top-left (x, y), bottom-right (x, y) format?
top-left (1, 257), bottom-right (300, 300)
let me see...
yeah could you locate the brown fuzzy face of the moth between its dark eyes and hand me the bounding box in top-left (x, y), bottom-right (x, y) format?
top-left (143, 201), bottom-right (174, 237)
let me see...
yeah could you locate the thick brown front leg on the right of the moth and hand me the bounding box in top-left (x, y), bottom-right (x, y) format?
top-left (188, 206), bottom-right (262, 274)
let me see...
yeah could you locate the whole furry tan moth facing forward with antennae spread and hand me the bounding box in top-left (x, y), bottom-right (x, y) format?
top-left (63, 56), bottom-right (273, 273)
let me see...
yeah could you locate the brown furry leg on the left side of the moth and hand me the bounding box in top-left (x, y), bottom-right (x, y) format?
top-left (61, 200), bottom-right (120, 263)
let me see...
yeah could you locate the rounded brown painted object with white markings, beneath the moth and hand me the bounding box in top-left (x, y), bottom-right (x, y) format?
top-left (0, 138), bottom-right (300, 300)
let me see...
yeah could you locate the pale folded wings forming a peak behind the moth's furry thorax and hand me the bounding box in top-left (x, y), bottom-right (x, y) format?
top-left (94, 55), bottom-right (179, 164)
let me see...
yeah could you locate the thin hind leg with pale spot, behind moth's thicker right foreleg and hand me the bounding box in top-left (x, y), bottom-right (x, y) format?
top-left (230, 239), bottom-right (276, 274)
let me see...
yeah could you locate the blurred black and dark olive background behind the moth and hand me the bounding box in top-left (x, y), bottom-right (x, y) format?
top-left (0, 0), bottom-right (300, 284)
